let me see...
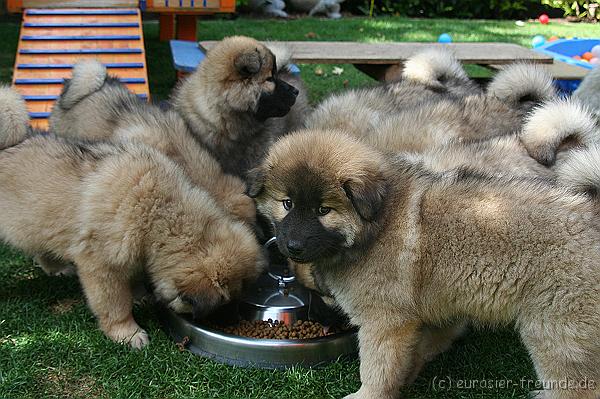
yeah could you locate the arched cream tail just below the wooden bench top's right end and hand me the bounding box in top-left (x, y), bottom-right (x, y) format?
top-left (487, 64), bottom-right (556, 107)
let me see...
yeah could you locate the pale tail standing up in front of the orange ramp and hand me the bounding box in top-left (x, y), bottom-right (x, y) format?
top-left (58, 60), bottom-right (106, 110)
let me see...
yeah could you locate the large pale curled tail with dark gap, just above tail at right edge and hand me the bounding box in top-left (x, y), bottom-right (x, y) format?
top-left (521, 100), bottom-right (598, 165)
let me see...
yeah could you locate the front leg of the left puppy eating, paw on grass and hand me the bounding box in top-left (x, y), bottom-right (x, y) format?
top-left (76, 259), bottom-right (149, 349)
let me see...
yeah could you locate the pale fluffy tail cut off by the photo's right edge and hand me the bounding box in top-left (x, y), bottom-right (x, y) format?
top-left (555, 144), bottom-right (600, 196)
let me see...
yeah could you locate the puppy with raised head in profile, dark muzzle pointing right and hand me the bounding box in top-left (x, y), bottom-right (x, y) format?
top-left (172, 36), bottom-right (307, 177)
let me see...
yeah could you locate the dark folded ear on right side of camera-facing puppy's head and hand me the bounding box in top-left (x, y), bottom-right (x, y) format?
top-left (342, 174), bottom-right (388, 222)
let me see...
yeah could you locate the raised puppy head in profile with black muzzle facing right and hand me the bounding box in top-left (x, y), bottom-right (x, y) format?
top-left (200, 36), bottom-right (298, 121)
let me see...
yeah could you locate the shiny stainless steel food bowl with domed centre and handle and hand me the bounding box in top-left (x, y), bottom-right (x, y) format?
top-left (160, 238), bottom-right (358, 369)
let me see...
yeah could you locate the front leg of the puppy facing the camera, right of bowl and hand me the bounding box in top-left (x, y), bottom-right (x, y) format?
top-left (345, 321), bottom-right (420, 399)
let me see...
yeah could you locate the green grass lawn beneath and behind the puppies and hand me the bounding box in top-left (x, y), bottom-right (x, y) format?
top-left (0, 14), bottom-right (600, 399)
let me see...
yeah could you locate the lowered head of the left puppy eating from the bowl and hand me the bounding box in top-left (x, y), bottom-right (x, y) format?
top-left (151, 220), bottom-right (265, 318)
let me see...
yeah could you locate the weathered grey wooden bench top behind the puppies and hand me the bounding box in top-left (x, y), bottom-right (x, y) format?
top-left (200, 41), bottom-right (553, 65)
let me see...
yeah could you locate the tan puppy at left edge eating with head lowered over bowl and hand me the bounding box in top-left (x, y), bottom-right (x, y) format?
top-left (0, 89), bottom-right (263, 348)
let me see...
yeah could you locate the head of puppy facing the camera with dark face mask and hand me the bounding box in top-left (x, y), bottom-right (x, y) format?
top-left (249, 130), bottom-right (388, 263)
